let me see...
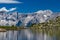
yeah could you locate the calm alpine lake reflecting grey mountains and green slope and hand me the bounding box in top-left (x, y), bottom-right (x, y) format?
top-left (0, 28), bottom-right (60, 40)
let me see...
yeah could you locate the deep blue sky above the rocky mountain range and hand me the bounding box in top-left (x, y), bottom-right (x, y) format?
top-left (0, 0), bottom-right (60, 13)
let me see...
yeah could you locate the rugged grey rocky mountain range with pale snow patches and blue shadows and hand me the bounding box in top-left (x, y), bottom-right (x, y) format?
top-left (0, 10), bottom-right (60, 26)
